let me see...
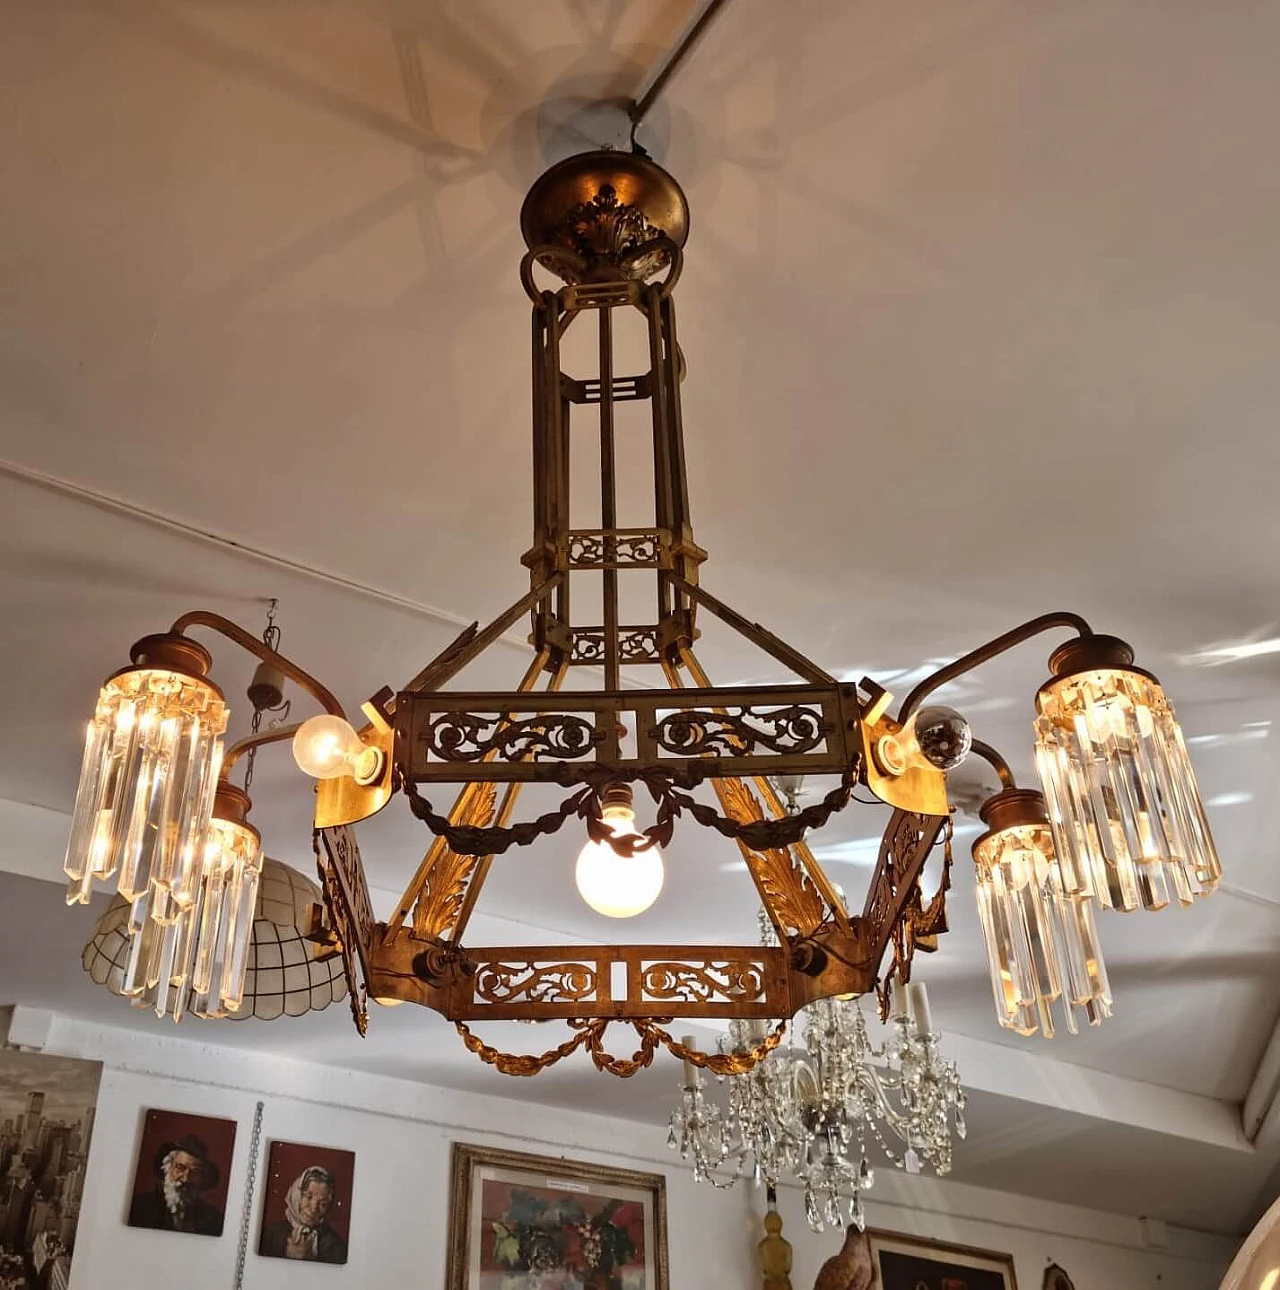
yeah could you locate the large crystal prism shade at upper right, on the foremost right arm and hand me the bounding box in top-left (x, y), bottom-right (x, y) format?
top-left (1036, 668), bottom-right (1222, 911)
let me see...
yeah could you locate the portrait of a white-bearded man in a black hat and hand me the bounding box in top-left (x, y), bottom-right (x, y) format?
top-left (129, 1111), bottom-right (236, 1236)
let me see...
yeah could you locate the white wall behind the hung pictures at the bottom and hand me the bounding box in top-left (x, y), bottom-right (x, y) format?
top-left (22, 1018), bottom-right (1232, 1290)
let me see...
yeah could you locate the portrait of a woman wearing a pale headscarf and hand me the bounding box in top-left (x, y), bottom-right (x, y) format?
top-left (258, 1142), bottom-right (356, 1263)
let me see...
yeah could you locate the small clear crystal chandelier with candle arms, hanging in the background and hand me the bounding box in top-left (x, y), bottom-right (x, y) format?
top-left (667, 983), bottom-right (965, 1232)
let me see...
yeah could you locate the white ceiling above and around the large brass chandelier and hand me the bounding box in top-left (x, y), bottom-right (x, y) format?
top-left (0, 0), bottom-right (1280, 1231)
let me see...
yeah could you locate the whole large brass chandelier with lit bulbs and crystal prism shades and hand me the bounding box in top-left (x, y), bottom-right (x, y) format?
top-left (66, 151), bottom-right (1219, 1076)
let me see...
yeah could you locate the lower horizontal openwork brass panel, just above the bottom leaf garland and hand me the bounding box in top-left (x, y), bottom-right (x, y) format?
top-left (448, 946), bottom-right (790, 1020)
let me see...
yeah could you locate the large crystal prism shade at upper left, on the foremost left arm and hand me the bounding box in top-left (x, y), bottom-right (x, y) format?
top-left (63, 668), bottom-right (227, 921)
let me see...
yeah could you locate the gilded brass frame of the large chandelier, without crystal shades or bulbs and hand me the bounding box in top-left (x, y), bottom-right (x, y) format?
top-left (142, 154), bottom-right (1089, 1075)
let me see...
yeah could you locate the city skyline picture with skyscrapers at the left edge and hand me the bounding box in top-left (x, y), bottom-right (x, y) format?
top-left (0, 1049), bottom-right (102, 1290)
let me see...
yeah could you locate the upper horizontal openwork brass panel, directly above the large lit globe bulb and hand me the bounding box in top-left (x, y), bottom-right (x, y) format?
top-left (395, 685), bottom-right (857, 783)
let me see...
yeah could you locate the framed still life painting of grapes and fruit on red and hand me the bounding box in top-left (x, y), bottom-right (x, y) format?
top-left (445, 1143), bottom-right (668, 1290)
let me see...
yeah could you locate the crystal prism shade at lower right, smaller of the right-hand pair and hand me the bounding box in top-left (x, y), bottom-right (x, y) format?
top-left (973, 824), bottom-right (1111, 1038)
